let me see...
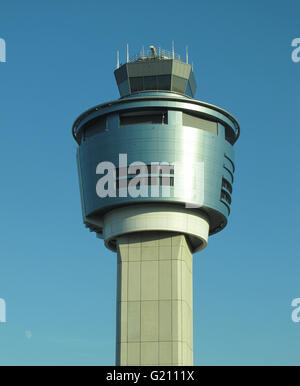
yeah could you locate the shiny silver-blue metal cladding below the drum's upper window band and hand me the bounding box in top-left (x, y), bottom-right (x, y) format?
top-left (75, 97), bottom-right (237, 233)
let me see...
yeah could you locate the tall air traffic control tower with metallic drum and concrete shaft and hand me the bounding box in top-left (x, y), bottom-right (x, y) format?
top-left (73, 46), bottom-right (240, 366)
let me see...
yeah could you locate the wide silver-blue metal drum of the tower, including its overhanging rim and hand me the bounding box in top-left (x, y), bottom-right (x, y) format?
top-left (73, 92), bottom-right (239, 247)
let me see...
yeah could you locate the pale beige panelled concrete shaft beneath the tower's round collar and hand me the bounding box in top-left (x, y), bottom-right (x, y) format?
top-left (116, 232), bottom-right (193, 366)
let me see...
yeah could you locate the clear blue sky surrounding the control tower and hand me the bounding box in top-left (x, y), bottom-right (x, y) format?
top-left (0, 0), bottom-right (300, 365)
